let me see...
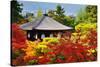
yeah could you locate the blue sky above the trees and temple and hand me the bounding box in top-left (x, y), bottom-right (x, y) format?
top-left (19, 1), bottom-right (86, 16)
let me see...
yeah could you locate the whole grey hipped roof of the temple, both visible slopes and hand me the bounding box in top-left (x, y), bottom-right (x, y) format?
top-left (20, 16), bottom-right (72, 30)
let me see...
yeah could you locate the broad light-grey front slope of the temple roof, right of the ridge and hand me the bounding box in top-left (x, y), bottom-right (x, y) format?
top-left (35, 16), bottom-right (72, 30)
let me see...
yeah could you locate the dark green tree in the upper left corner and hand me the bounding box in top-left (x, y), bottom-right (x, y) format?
top-left (11, 0), bottom-right (23, 23)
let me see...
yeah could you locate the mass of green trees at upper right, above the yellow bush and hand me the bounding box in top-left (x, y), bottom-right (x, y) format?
top-left (75, 5), bottom-right (97, 25)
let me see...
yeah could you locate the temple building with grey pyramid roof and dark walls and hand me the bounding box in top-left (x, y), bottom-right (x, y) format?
top-left (20, 14), bottom-right (72, 40)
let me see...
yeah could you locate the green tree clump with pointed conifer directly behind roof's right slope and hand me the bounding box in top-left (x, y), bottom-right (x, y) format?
top-left (48, 5), bottom-right (75, 27)
